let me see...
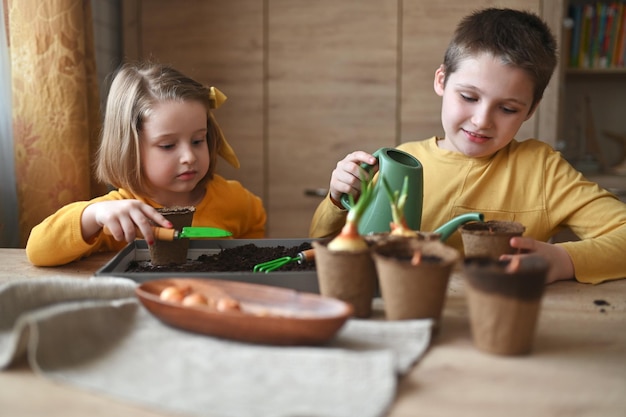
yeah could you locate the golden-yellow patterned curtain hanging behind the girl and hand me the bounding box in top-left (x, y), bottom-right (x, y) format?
top-left (8, 0), bottom-right (106, 246)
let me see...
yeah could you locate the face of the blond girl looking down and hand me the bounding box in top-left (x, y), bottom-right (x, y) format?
top-left (139, 101), bottom-right (210, 206)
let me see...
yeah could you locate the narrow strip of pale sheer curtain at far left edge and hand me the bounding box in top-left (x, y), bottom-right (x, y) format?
top-left (0, 3), bottom-right (20, 248)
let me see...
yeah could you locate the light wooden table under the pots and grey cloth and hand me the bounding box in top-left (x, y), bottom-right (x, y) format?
top-left (0, 249), bottom-right (626, 417)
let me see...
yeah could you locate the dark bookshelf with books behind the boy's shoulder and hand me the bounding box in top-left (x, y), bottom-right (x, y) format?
top-left (559, 0), bottom-right (626, 178)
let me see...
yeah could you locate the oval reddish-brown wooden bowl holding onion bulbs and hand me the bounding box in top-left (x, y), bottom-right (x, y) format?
top-left (136, 278), bottom-right (352, 345)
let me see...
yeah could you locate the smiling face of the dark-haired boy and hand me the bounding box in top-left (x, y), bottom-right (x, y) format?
top-left (434, 54), bottom-right (534, 157)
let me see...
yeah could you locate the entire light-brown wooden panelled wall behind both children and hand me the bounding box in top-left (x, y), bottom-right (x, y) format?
top-left (123, 0), bottom-right (556, 238)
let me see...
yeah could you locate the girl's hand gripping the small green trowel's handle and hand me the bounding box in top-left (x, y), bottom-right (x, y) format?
top-left (81, 200), bottom-right (172, 245)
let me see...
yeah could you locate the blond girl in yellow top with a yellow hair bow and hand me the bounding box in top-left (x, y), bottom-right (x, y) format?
top-left (26, 64), bottom-right (266, 266)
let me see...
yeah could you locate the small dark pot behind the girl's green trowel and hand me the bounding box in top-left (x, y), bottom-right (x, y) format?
top-left (149, 206), bottom-right (196, 265)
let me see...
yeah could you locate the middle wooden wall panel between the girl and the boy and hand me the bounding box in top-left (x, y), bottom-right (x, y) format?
top-left (266, 0), bottom-right (398, 237)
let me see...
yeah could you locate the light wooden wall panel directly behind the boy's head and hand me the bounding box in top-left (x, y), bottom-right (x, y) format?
top-left (400, 0), bottom-right (540, 142)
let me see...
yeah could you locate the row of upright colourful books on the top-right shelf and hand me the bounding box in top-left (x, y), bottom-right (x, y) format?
top-left (566, 0), bottom-right (626, 69)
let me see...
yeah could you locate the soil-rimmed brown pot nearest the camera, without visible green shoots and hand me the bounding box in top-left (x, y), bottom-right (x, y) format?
top-left (463, 255), bottom-right (549, 355)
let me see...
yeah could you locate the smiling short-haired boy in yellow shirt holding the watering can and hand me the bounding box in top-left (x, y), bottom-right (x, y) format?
top-left (310, 8), bottom-right (626, 283)
